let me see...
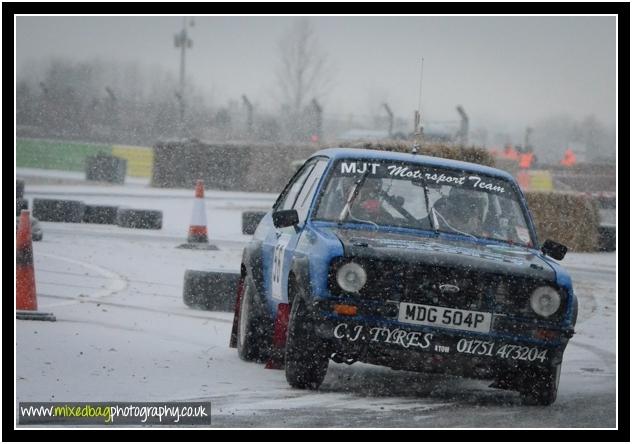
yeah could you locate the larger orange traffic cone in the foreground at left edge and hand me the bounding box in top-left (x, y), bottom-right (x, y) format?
top-left (15, 210), bottom-right (55, 321)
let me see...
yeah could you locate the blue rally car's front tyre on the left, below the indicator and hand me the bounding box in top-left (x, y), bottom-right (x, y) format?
top-left (285, 298), bottom-right (329, 390)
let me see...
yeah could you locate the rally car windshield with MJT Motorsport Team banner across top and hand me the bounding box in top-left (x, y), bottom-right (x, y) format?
top-left (313, 159), bottom-right (534, 247)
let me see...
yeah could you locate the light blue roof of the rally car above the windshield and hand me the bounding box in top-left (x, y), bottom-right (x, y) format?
top-left (310, 148), bottom-right (515, 182)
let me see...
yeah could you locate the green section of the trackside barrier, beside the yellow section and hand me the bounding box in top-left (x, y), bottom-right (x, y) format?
top-left (15, 139), bottom-right (112, 171)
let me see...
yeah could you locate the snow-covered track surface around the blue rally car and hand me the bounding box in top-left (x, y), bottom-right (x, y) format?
top-left (16, 170), bottom-right (617, 427)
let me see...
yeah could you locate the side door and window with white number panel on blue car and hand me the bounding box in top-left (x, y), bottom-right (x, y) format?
top-left (264, 157), bottom-right (328, 312)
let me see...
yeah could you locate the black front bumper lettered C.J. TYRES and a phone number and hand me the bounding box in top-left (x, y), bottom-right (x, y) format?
top-left (312, 302), bottom-right (572, 378)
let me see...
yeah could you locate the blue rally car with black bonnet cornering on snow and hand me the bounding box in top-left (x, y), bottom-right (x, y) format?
top-left (231, 148), bottom-right (578, 405)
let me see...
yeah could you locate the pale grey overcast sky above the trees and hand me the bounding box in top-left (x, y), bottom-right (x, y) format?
top-left (16, 16), bottom-right (616, 132)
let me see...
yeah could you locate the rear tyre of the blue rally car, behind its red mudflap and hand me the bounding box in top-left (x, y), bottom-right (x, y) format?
top-left (237, 276), bottom-right (272, 361)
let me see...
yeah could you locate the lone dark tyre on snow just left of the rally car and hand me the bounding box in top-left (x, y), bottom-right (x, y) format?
top-left (182, 270), bottom-right (241, 312)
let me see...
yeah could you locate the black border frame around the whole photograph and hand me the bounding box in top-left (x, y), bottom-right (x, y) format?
top-left (2, 2), bottom-right (630, 442)
